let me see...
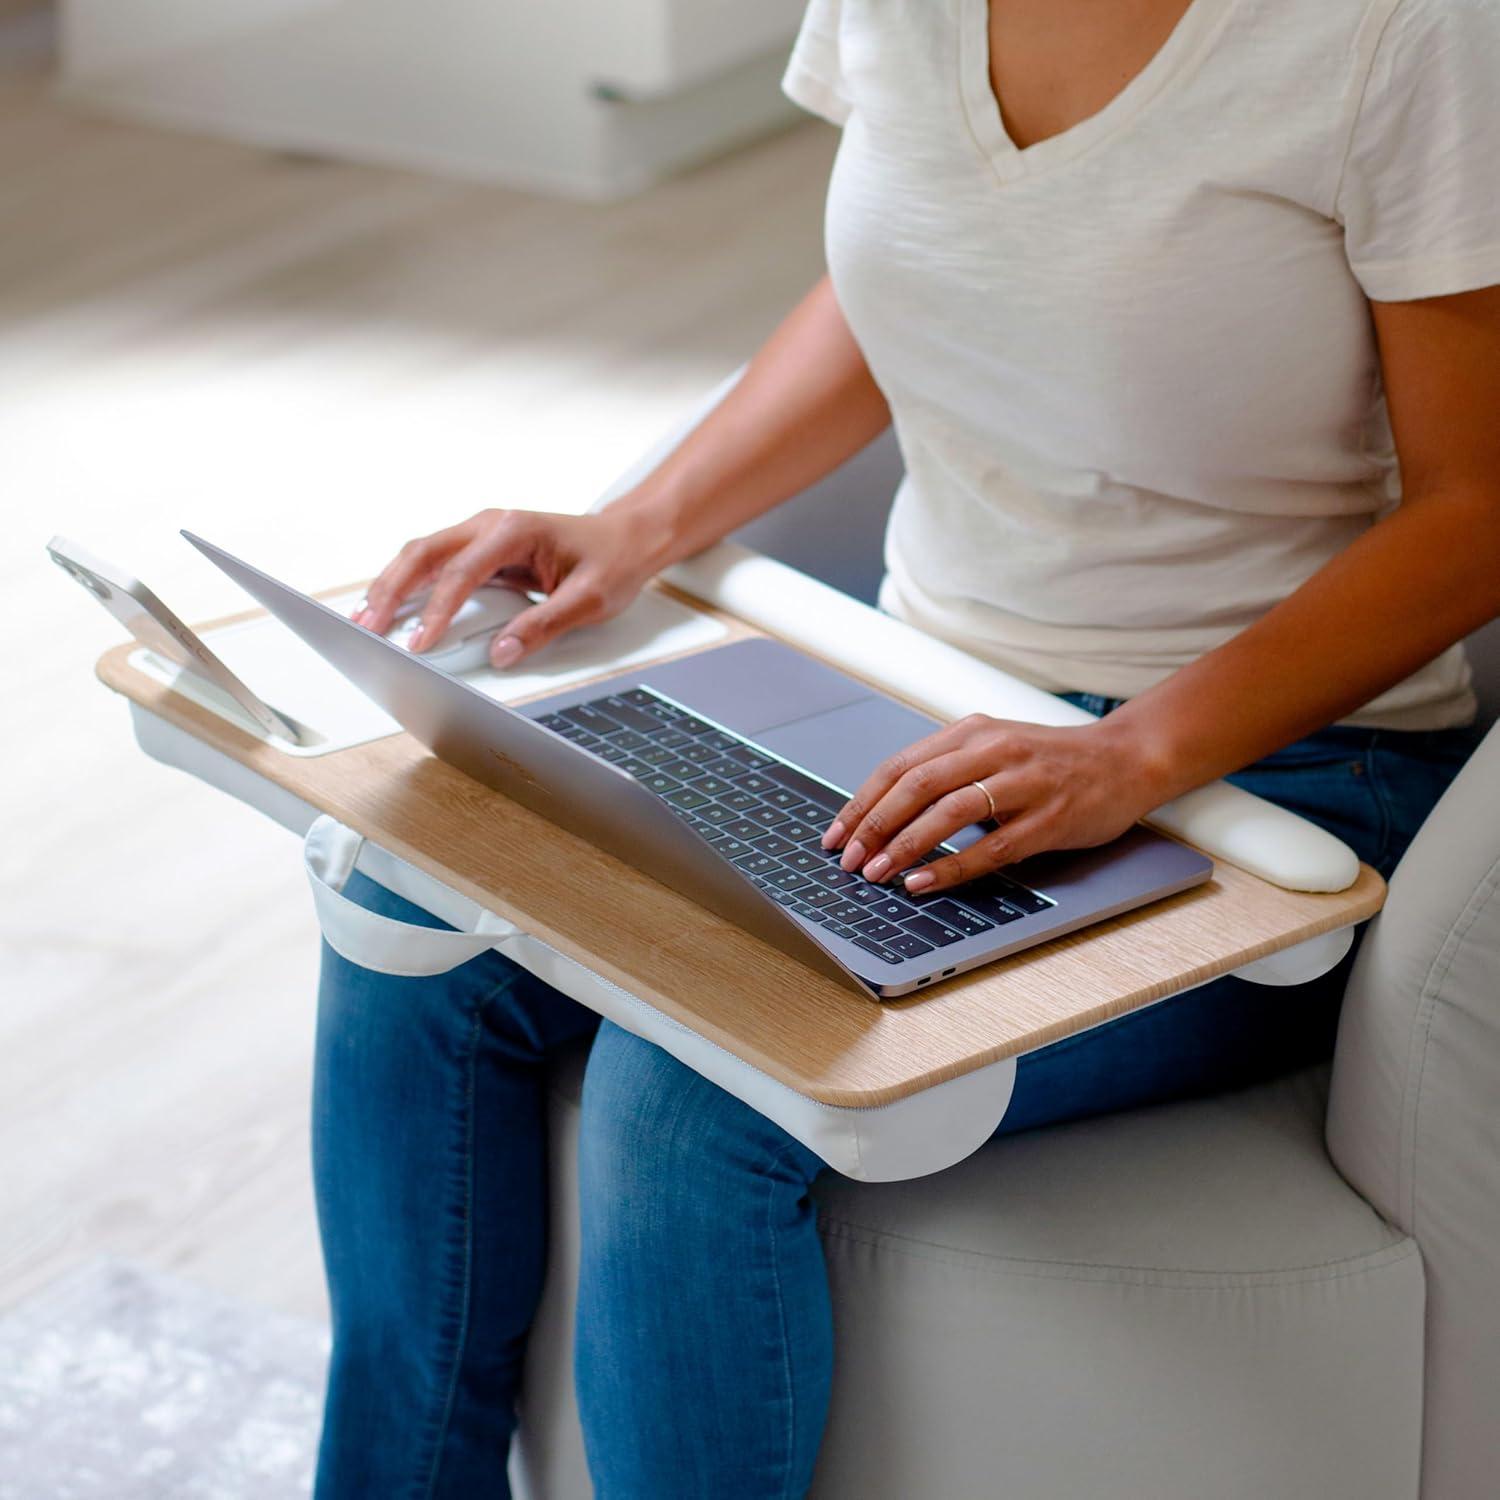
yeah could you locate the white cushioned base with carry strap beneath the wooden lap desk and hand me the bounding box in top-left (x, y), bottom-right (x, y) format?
top-left (131, 702), bottom-right (1353, 1182)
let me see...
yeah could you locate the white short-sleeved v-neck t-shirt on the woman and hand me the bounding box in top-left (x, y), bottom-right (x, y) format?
top-left (785, 0), bottom-right (1500, 729)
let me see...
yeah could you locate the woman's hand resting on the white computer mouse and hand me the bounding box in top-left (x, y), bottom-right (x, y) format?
top-left (354, 507), bottom-right (657, 668)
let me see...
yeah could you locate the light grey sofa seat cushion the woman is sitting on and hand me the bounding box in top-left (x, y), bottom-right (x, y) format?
top-left (515, 1055), bottom-right (1424, 1500)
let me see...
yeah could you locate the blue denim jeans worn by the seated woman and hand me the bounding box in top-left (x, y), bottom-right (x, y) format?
top-left (314, 696), bottom-right (1475, 1500)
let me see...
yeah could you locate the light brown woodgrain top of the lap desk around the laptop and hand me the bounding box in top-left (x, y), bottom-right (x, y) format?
top-left (98, 590), bottom-right (1385, 1107)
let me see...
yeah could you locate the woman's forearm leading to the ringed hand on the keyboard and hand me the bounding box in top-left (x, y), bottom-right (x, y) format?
top-left (1107, 489), bottom-right (1500, 801)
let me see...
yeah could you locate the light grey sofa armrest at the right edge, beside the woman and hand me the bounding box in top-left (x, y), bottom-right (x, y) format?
top-left (1328, 728), bottom-right (1500, 1500)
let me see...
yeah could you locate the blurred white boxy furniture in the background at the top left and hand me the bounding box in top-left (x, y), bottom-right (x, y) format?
top-left (60, 0), bottom-right (803, 198)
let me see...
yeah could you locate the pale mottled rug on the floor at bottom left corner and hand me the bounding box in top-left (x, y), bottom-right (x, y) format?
top-left (0, 1262), bottom-right (327, 1500)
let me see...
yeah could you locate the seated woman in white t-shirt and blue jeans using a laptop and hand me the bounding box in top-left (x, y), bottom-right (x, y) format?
top-left (317, 0), bottom-right (1500, 1500)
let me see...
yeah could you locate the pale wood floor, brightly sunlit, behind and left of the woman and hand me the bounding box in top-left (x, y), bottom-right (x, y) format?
top-left (0, 64), bottom-right (833, 1314)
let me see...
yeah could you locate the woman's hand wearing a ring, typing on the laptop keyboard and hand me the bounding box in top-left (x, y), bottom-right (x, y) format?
top-left (824, 714), bottom-right (1167, 893)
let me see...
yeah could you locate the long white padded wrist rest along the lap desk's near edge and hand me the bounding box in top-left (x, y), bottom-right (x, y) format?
top-left (663, 542), bottom-right (1359, 891)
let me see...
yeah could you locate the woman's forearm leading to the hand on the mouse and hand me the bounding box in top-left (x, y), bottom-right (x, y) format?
top-left (611, 276), bottom-right (891, 569)
